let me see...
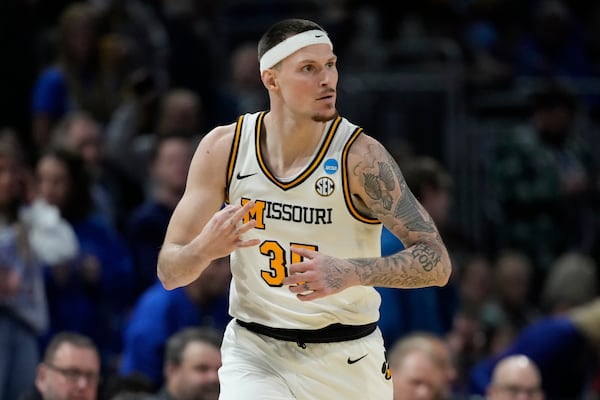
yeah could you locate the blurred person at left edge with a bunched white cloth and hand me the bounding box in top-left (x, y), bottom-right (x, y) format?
top-left (0, 129), bottom-right (77, 400)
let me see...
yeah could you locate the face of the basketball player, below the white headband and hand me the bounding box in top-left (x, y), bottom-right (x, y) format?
top-left (279, 44), bottom-right (338, 121)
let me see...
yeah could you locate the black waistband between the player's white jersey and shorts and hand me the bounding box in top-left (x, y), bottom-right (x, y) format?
top-left (236, 319), bottom-right (377, 348)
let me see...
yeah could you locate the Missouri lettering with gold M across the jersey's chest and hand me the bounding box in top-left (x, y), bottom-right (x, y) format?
top-left (242, 198), bottom-right (332, 229)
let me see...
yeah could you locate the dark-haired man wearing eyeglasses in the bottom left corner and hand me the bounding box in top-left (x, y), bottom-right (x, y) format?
top-left (23, 332), bottom-right (100, 400)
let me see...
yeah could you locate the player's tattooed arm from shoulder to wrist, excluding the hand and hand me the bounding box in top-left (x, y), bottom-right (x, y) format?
top-left (349, 135), bottom-right (451, 288)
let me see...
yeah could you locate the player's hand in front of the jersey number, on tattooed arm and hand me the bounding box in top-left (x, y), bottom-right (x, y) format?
top-left (283, 246), bottom-right (358, 301)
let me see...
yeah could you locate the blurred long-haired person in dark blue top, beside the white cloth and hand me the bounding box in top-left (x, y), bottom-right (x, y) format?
top-left (36, 149), bottom-right (134, 374)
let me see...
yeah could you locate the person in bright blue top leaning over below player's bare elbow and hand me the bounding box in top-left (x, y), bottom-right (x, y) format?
top-left (120, 257), bottom-right (231, 388)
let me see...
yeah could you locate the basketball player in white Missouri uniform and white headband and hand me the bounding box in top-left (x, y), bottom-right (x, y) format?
top-left (158, 19), bottom-right (451, 400)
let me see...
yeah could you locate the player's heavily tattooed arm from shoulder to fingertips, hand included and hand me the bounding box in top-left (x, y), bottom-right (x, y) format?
top-left (283, 135), bottom-right (451, 301)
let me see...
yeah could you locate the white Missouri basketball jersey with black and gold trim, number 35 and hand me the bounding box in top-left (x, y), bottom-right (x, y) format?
top-left (227, 112), bottom-right (382, 329)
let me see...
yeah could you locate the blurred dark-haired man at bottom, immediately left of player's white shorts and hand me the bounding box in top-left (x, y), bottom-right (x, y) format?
top-left (153, 328), bottom-right (222, 400)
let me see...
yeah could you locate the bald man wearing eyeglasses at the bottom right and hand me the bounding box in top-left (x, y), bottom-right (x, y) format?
top-left (487, 354), bottom-right (544, 400)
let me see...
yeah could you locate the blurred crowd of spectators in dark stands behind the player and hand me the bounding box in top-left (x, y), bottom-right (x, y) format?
top-left (0, 0), bottom-right (600, 400)
